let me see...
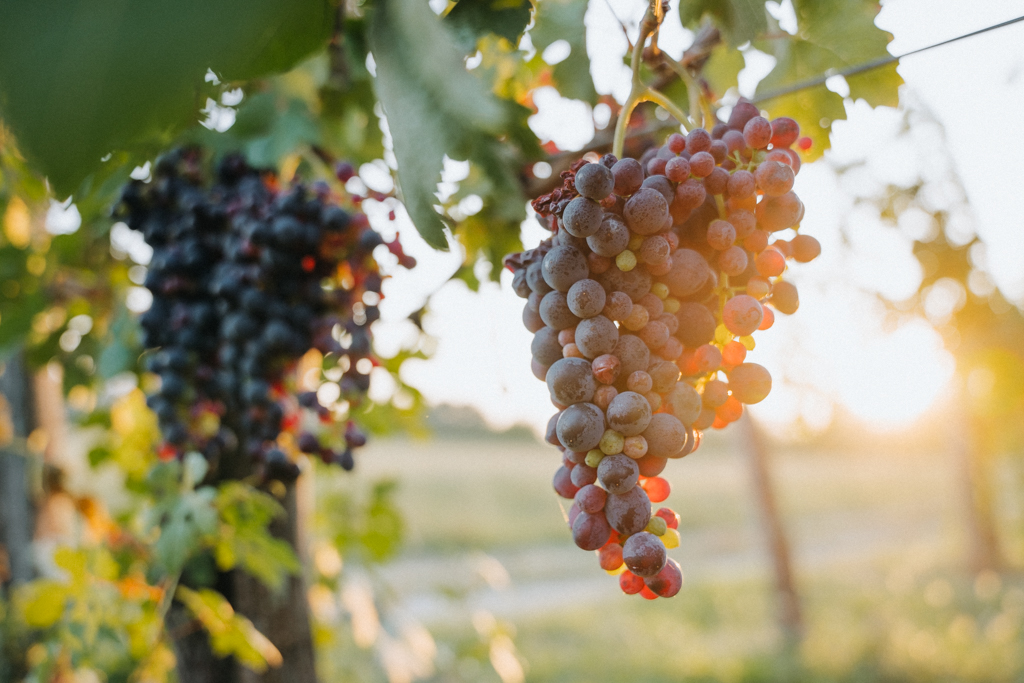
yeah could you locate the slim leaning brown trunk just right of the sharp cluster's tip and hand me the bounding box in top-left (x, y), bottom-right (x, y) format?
top-left (739, 414), bottom-right (804, 643)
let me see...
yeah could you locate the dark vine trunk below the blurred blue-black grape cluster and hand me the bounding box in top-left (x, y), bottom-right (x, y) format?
top-left (167, 484), bottom-right (316, 683)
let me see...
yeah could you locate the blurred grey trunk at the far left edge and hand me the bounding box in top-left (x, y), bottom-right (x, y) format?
top-left (0, 353), bottom-right (36, 587)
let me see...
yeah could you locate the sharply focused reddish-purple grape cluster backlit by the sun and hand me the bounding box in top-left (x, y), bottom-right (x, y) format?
top-left (506, 102), bottom-right (820, 599)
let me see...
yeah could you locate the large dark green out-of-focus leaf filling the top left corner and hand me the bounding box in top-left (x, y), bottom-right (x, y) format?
top-left (0, 0), bottom-right (334, 196)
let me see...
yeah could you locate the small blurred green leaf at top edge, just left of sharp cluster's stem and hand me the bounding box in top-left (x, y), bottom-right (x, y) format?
top-left (529, 0), bottom-right (597, 104)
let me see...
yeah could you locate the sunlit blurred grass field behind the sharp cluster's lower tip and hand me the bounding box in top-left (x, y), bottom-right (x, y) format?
top-left (315, 417), bottom-right (1024, 683)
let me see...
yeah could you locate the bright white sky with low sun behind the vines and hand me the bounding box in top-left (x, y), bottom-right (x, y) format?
top-left (360, 0), bottom-right (1024, 438)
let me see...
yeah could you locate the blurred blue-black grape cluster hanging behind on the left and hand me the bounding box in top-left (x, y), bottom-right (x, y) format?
top-left (116, 148), bottom-right (413, 480)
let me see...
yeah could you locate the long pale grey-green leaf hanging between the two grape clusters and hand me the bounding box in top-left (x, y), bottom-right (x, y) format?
top-left (370, 0), bottom-right (506, 249)
